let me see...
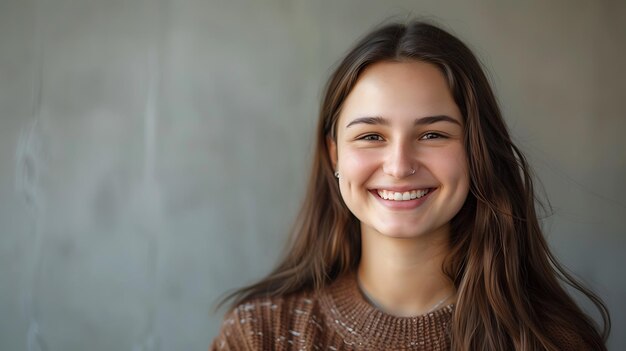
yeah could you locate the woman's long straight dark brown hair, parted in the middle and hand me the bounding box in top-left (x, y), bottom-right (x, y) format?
top-left (218, 22), bottom-right (610, 351)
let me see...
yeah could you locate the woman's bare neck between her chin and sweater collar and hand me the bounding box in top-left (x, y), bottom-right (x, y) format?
top-left (357, 228), bottom-right (455, 317)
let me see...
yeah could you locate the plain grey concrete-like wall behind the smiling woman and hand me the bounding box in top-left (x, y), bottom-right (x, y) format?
top-left (0, 0), bottom-right (626, 351)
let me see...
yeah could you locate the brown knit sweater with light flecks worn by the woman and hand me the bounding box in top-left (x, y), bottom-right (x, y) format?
top-left (210, 276), bottom-right (454, 351)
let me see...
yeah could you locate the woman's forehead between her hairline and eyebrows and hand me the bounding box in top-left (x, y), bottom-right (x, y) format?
top-left (339, 61), bottom-right (462, 127)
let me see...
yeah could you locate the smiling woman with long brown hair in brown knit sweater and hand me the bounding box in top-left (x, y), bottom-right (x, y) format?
top-left (211, 22), bottom-right (610, 351)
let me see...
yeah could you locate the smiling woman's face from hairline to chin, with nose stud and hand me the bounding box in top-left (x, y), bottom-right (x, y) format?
top-left (329, 61), bottom-right (469, 242)
